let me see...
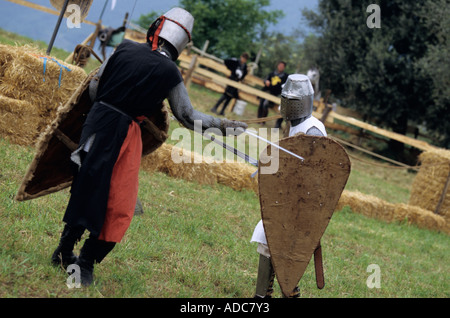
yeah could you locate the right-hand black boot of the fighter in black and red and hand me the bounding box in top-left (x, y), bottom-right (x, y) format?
top-left (75, 237), bottom-right (116, 287)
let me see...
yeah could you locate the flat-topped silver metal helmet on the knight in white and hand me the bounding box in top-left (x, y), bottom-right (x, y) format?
top-left (280, 74), bottom-right (314, 120)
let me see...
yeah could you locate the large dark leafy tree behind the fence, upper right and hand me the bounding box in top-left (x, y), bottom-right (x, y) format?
top-left (303, 0), bottom-right (448, 154)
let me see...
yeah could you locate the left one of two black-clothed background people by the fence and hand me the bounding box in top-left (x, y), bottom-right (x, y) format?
top-left (211, 53), bottom-right (248, 115)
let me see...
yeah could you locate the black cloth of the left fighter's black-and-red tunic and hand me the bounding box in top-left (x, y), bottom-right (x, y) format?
top-left (64, 40), bottom-right (182, 236)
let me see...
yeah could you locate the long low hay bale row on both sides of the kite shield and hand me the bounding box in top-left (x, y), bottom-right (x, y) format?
top-left (142, 144), bottom-right (450, 234)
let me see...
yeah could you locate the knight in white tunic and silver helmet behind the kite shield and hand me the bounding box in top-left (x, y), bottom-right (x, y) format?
top-left (251, 74), bottom-right (327, 298)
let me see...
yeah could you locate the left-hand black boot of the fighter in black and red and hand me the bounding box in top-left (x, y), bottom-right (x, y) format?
top-left (52, 224), bottom-right (84, 269)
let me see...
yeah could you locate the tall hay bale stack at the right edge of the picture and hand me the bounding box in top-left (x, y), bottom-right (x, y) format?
top-left (409, 149), bottom-right (450, 232)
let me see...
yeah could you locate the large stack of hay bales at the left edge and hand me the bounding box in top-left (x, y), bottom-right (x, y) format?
top-left (0, 45), bottom-right (87, 145)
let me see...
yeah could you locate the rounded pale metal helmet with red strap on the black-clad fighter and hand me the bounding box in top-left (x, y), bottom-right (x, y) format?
top-left (147, 8), bottom-right (194, 59)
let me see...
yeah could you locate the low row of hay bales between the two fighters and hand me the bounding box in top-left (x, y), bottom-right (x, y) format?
top-left (142, 144), bottom-right (258, 192)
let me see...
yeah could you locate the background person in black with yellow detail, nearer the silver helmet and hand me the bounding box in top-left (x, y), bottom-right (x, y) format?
top-left (258, 61), bottom-right (288, 128)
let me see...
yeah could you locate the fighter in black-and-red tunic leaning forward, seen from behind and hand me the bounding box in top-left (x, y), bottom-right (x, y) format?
top-left (52, 8), bottom-right (247, 286)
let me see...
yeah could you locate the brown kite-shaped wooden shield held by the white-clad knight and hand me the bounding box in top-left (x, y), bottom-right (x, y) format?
top-left (258, 134), bottom-right (351, 295)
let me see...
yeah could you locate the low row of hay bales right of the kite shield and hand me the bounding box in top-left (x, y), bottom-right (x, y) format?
top-left (336, 190), bottom-right (450, 234)
